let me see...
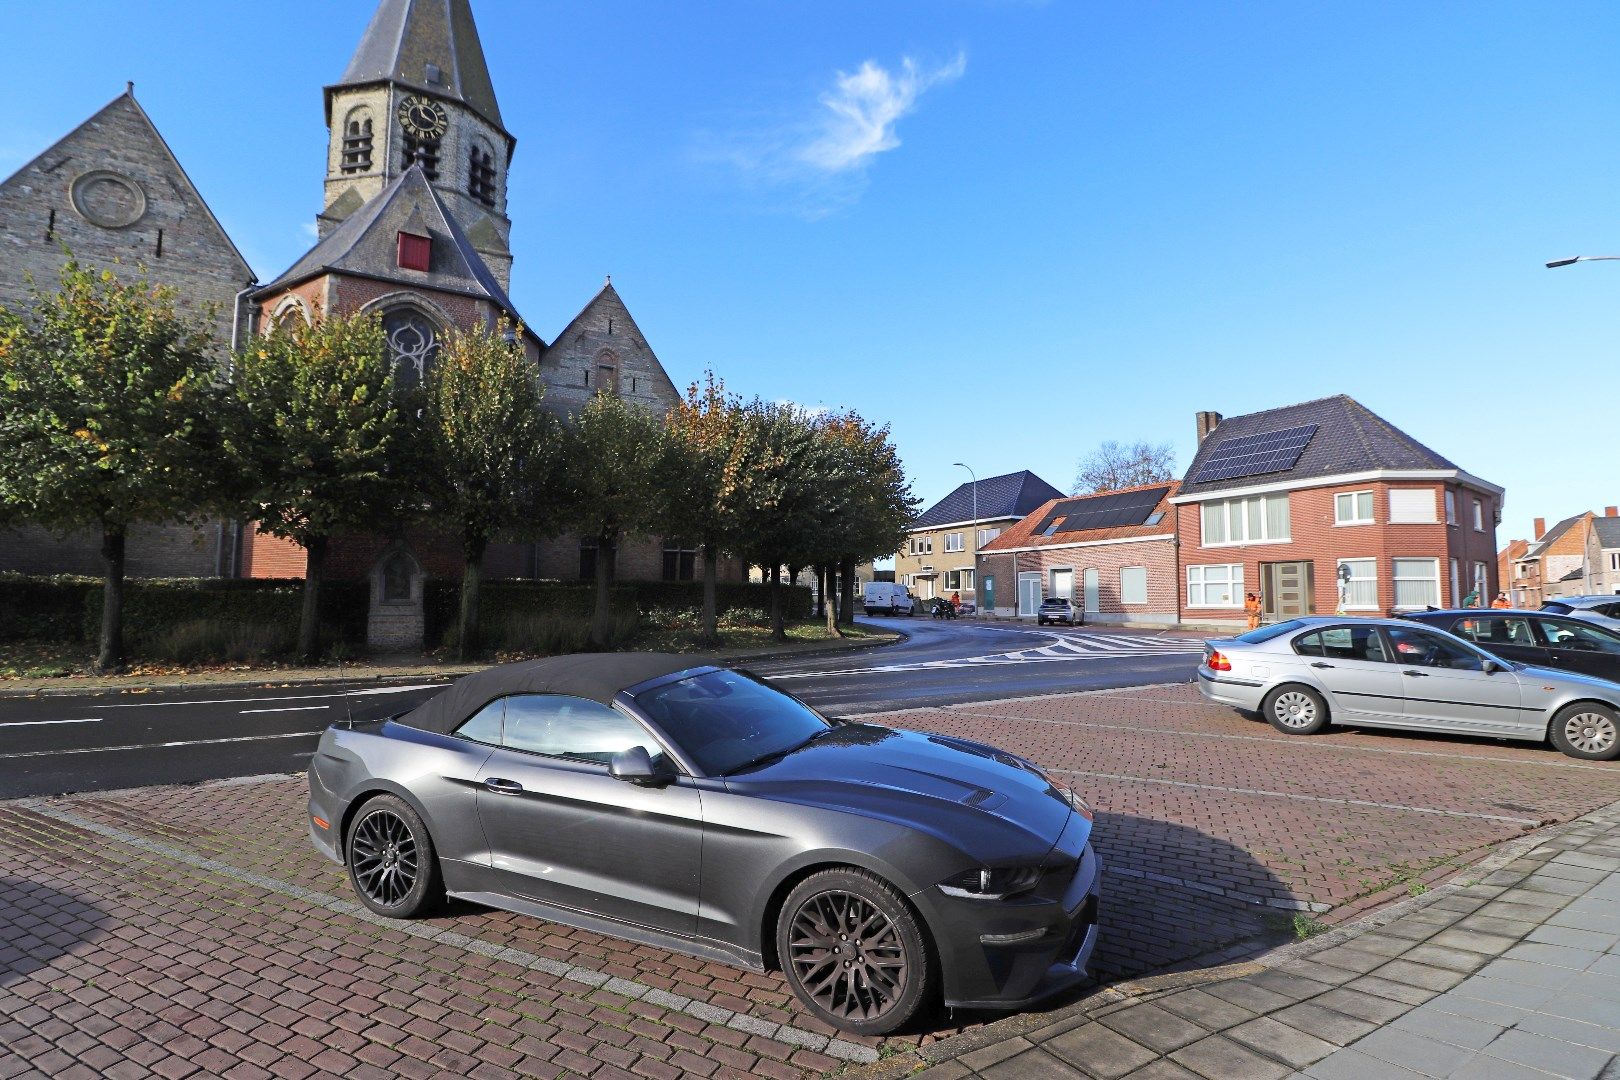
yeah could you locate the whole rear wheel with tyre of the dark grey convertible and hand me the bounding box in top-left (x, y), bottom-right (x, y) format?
top-left (343, 795), bottom-right (444, 918)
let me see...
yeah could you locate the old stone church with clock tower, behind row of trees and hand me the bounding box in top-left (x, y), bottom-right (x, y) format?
top-left (0, 0), bottom-right (742, 592)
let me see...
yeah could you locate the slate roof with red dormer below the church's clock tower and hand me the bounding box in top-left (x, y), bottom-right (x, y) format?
top-left (259, 165), bottom-right (522, 333)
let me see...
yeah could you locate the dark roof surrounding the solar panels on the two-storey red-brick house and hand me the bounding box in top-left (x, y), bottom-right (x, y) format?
top-left (1181, 393), bottom-right (1458, 495)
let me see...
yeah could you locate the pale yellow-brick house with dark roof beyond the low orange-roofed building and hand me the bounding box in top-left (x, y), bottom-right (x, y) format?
top-left (894, 470), bottom-right (1063, 610)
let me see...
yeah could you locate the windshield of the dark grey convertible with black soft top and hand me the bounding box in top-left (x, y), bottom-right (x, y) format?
top-left (635, 672), bottom-right (833, 776)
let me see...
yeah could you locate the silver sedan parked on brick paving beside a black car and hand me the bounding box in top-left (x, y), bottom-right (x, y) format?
top-left (1199, 617), bottom-right (1620, 761)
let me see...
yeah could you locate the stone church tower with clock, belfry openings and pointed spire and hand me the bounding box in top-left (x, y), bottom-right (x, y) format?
top-left (316, 0), bottom-right (517, 290)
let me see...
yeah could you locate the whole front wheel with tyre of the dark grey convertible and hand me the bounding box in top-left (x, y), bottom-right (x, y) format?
top-left (776, 868), bottom-right (938, 1035)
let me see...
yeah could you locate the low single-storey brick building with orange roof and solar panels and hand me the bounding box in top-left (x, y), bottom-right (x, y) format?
top-left (978, 483), bottom-right (1179, 627)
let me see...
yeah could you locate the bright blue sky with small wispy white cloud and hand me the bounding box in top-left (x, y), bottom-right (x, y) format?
top-left (0, 0), bottom-right (1620, 542)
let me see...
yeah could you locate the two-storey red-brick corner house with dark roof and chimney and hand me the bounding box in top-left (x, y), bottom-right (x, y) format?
top-left (1171, 395), bottom-right (1503, 627)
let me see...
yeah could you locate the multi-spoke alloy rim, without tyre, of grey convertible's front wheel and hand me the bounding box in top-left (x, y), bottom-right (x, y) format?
top-left (789, 891), bottom-right (910, 1020)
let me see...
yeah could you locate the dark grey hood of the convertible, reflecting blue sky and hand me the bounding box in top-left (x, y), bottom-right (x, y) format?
top-left (726, 724), bottom-right (1090, 861)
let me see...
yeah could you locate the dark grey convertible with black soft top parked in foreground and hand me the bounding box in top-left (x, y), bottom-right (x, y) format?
top-left (309, 654), bottom-right (1100, 1035)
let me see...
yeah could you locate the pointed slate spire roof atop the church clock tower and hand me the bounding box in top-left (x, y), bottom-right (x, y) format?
top-left (326, 0), bottom-right (505, 131)
